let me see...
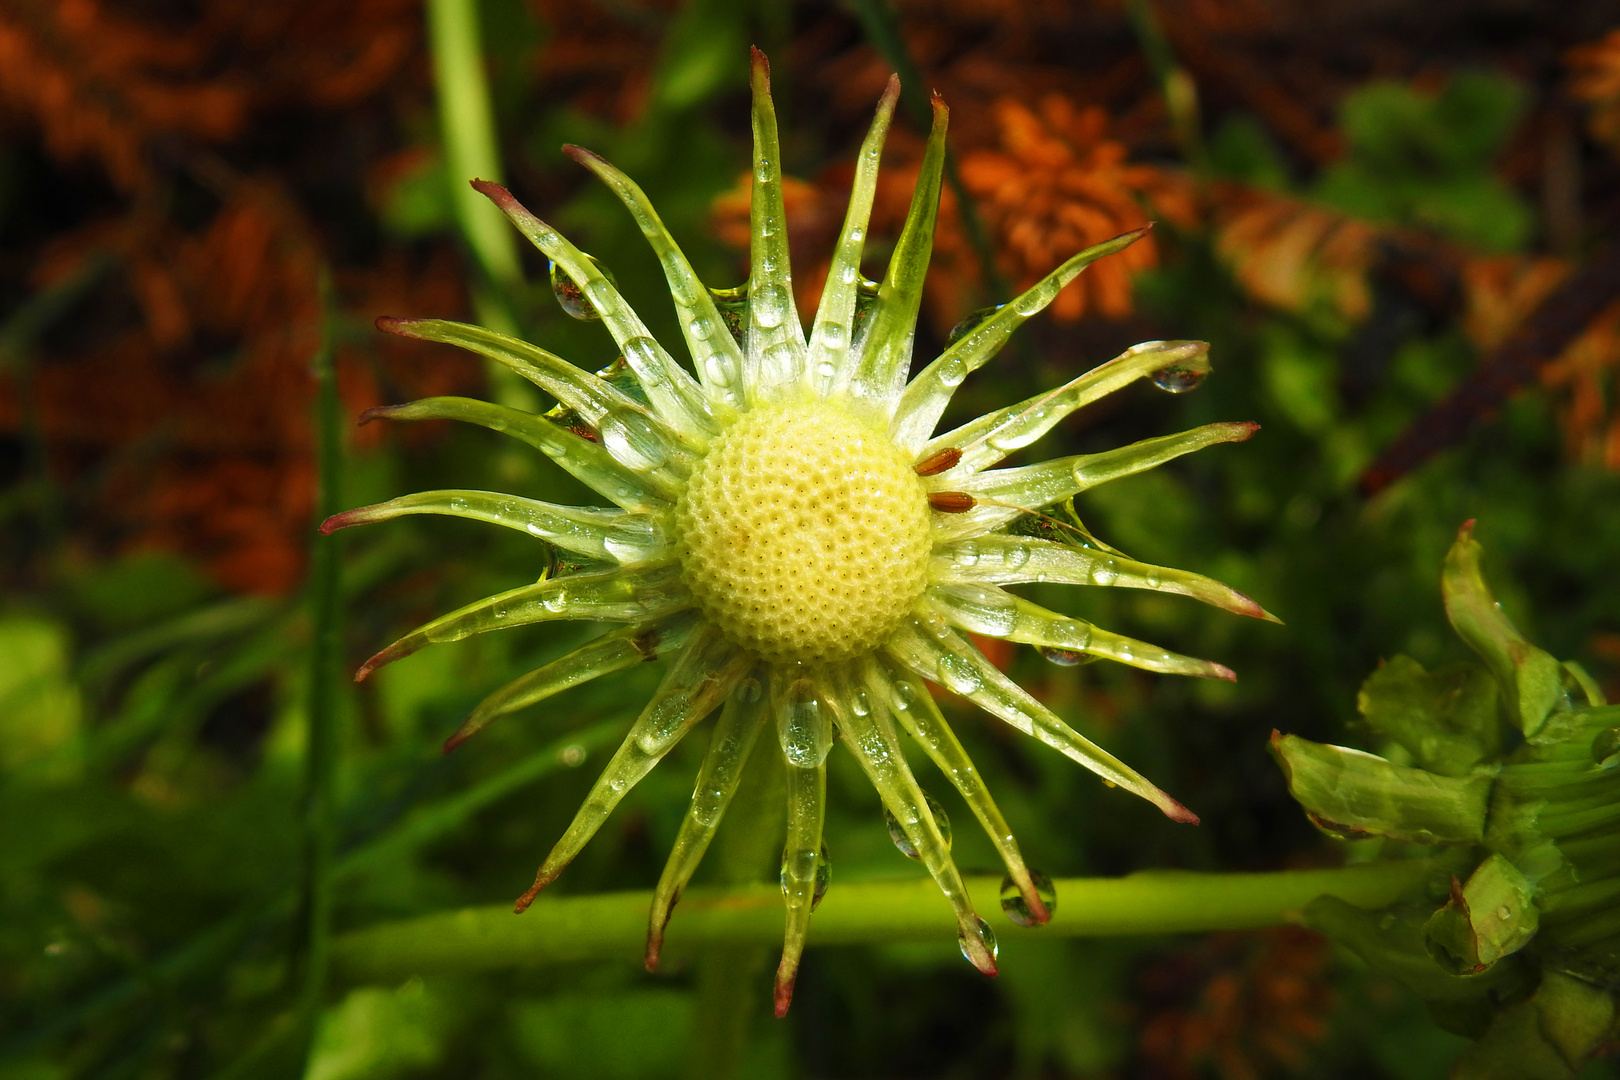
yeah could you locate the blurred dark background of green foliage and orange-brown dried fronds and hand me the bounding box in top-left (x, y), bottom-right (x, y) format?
top-left (0, 0), bottom-right (1620, 1080)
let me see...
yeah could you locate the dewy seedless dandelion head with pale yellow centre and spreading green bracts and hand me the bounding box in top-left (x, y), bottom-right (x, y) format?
top-left (322, 53), bottom-right (1268, 1012)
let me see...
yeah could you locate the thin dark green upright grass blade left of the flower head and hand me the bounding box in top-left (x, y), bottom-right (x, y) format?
top-left (298, 274), bottom-right (343, 1072)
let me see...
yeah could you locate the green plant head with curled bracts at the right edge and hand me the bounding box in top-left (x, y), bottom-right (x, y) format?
top-left (1272, 521), bottom-right (1620, 1080)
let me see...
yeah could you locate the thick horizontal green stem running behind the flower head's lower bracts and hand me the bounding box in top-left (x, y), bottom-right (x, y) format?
top-left (332, 860), bottom-right (1442, 983)
